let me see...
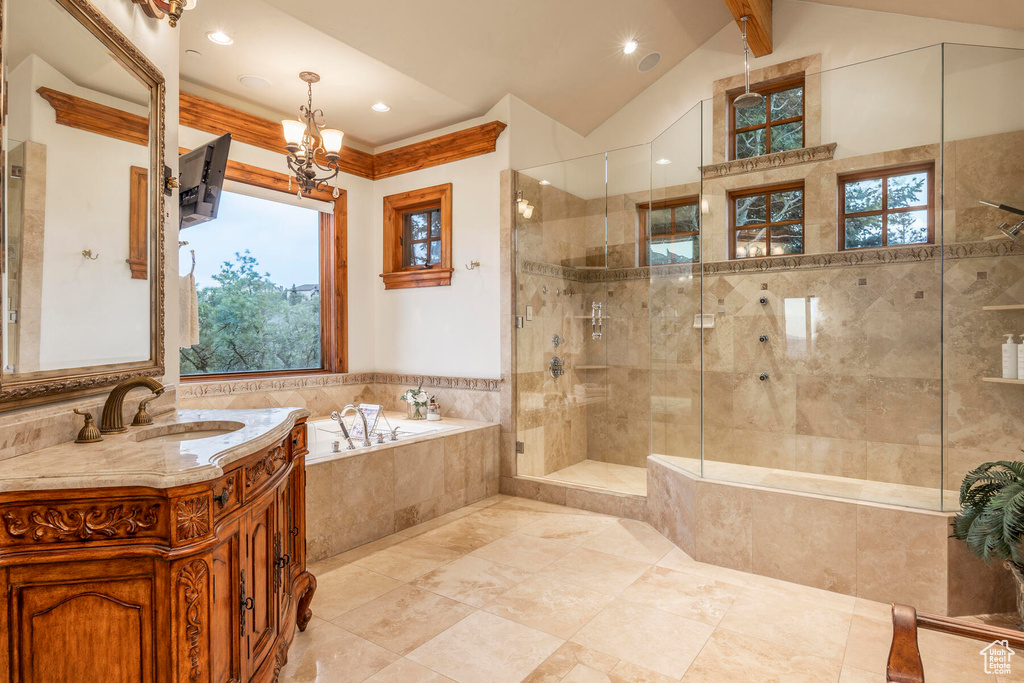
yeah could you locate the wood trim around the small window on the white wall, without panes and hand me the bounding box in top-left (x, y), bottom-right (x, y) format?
top-left (381, 182), bottom-right (455, 290)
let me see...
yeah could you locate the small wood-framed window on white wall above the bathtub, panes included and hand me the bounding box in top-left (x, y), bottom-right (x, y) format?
top-left (381, 183), bottom-right (453, 290)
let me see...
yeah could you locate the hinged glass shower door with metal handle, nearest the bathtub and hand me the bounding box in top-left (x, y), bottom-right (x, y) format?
top-left (515, 154), bottom-right (607, 478)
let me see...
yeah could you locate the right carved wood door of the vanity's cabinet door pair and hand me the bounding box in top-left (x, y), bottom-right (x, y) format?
top-left (243, 488), bottom-right (281, 677)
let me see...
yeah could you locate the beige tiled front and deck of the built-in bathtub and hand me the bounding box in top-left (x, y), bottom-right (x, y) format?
top-left (306, 414), bottom-right (500, 561)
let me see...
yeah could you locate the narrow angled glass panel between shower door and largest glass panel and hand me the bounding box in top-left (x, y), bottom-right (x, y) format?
top-left (651, 103), bottom-right (708, 474)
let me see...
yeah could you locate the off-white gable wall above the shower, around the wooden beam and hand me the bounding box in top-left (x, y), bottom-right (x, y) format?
top-left (587, 0), bottom-right (1024, 152)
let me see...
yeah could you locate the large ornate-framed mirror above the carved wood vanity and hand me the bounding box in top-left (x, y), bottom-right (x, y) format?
top-left (0, 0), bottom-right (164, 412)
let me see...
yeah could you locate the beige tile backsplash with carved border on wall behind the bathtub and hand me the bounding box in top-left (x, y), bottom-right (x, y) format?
top-left (180, 373), bottom-right (501, 422)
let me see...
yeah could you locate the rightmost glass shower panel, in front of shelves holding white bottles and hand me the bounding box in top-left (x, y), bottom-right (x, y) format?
top-left (942, 44), bottom-right (1024, 510)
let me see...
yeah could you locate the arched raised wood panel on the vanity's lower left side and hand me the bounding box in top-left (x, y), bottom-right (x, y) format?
top-left (9, 560), bottom-right (158, 683)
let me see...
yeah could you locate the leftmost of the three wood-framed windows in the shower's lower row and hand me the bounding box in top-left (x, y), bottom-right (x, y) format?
top-left (637, 197), bottom-right (700, 265)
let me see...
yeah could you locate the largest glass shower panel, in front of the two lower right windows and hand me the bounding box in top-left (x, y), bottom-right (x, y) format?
top-left (700, 47), bottom-right (942, 509)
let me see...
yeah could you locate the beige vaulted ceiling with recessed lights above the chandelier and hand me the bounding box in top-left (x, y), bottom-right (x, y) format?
top-left (180, 0), bottom-right (1024, 147)
